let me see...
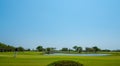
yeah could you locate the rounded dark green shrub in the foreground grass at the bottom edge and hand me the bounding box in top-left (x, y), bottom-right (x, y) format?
top-left (47, 60), bottom-right (83, 66)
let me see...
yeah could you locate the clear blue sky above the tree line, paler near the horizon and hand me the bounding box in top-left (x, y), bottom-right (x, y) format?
top-left (0, 0), bottom-right (120, 49)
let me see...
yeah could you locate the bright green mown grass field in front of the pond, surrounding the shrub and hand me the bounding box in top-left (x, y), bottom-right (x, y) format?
top-left (0, 52), bottom-right (120, 66)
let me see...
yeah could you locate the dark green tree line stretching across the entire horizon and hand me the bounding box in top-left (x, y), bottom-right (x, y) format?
top-left (0, 42), bottom-right (120, 54)
